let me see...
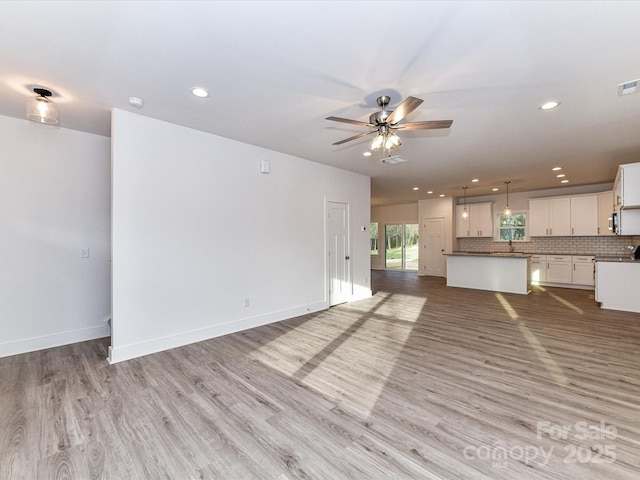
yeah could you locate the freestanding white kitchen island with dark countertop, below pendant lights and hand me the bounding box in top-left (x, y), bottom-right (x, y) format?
top-left (445, 252), bottom-right (531, 295)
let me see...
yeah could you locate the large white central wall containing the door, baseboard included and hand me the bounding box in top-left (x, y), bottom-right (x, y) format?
top-left (110, 110), bottom-right (371, 362)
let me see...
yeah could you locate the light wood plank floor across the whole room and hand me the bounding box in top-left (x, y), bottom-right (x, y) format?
top-left (0, 272), bottom-right (640, 480)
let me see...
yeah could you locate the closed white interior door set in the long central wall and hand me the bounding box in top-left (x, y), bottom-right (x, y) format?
top-left (328, 202), bottom-right (351, 305)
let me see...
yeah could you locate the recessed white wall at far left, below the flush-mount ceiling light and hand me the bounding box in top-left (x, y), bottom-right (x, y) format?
top-left (0, 116), bottom-right (111, 357)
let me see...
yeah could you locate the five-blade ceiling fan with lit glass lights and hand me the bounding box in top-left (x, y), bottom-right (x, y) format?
top-left (327, 95), bottom-right (453, 150)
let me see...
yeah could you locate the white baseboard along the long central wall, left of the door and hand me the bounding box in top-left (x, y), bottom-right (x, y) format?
top-left (108, 302), bottom-right (329, 364)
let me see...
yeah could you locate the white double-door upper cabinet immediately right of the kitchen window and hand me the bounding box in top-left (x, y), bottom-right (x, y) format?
top-left (529, 197), bottom-right (568, 237)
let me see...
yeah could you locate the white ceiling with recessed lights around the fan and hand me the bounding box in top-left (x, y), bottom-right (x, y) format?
top-left (0, 1), bottom-right (640, 205)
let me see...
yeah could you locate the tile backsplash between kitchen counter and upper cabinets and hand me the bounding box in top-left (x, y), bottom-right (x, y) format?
top-left (458, 235), bottom-right (640, 256)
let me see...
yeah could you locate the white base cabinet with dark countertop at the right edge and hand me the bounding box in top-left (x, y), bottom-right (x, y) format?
top-left (595, 256), bottom-right (640, 312)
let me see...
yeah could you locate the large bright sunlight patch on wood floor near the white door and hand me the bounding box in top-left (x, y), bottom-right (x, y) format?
top-left (251, 295), bottom-right (426, 418)
